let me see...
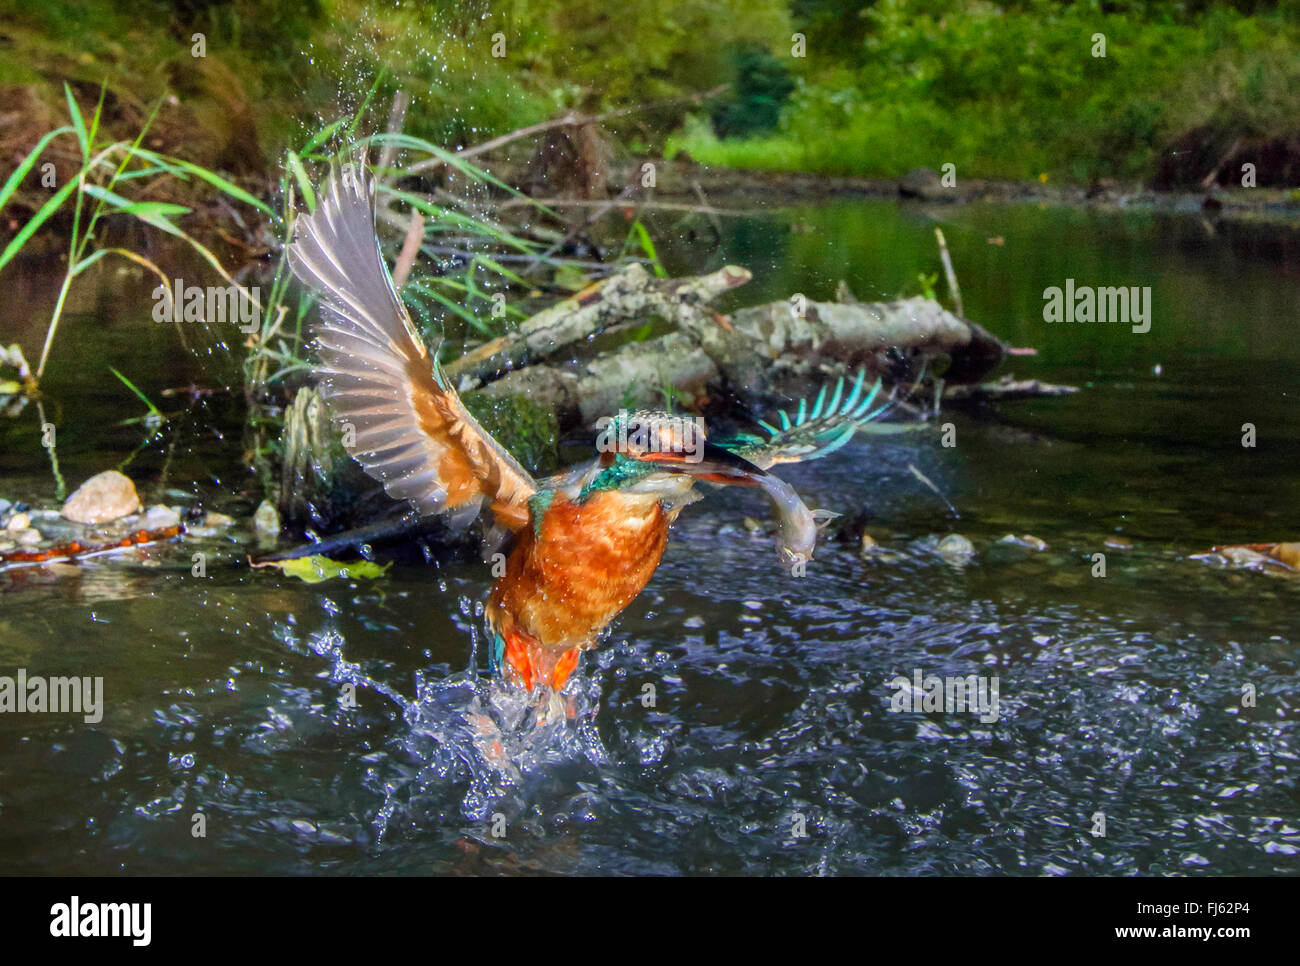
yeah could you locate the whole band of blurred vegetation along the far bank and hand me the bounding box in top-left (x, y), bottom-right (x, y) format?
top-left (0, 0), bottom-right (1300, 192)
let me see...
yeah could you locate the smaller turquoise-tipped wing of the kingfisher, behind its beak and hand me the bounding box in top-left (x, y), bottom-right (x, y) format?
top-left (719, 371), bottom-right (896, 469)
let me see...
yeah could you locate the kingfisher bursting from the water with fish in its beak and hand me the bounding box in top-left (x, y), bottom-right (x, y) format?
top-left (289, 163), bottom-right (889, 693)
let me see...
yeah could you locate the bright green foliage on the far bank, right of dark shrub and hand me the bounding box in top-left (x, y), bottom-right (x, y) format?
top-left (670, 0), bottom-right (1300, 181)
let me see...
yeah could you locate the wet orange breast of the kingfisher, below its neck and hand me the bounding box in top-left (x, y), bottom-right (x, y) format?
top-left (490, 491), bottom-right (670, 657)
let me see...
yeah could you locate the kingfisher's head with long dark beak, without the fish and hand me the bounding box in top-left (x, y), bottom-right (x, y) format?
top-left (588, 410), bottom-right (766, 491)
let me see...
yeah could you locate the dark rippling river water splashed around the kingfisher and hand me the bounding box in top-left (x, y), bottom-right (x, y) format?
top-left (0, 202), bottom-right (1300, 875)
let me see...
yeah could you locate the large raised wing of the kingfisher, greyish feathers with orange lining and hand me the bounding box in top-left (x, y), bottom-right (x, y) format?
top-left (289, 164), bottom-right (537, 530)
